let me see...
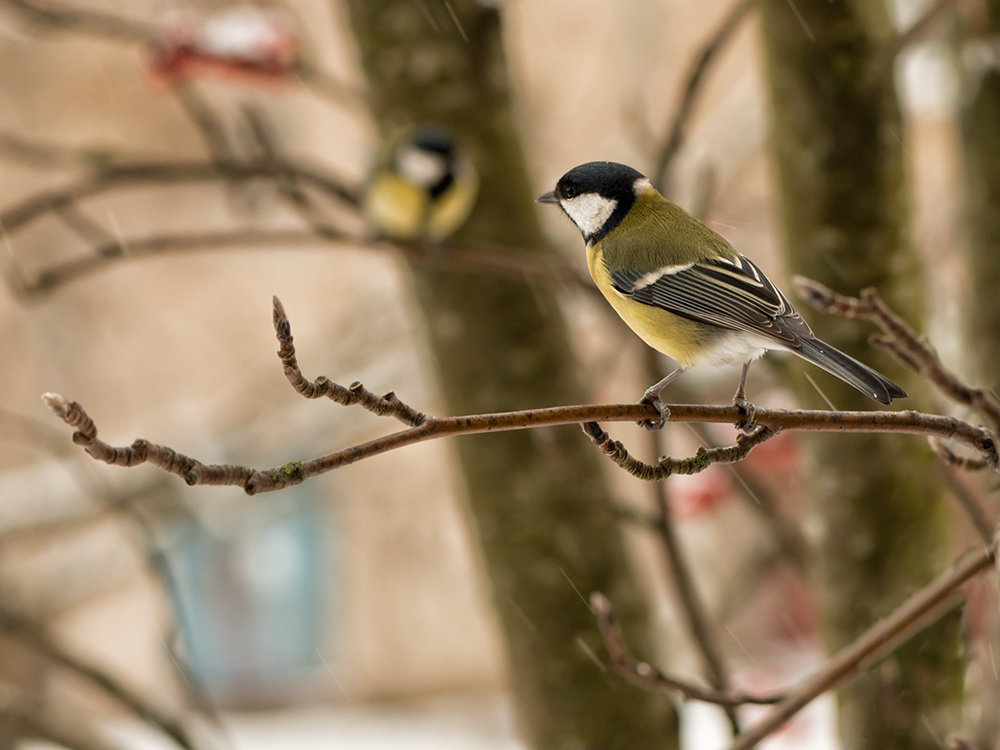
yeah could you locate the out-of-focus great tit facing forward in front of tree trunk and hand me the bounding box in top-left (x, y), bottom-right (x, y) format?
top-left (361, 125), bottom-right (479, 242)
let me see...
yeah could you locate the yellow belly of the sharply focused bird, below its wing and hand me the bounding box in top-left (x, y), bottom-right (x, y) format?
top-left (587, 247), bottom-right (720, 366)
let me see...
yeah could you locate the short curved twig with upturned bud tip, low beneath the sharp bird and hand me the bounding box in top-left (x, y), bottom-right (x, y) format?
top-left (590, 592), bottom-right (784, 708)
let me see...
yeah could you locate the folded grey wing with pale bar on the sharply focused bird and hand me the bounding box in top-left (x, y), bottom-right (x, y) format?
top-left (608, 255), bottom-right (814, 349)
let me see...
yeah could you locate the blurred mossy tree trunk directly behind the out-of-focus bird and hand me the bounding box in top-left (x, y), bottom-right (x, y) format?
top-left (348, 0), bottom-right (677, 750)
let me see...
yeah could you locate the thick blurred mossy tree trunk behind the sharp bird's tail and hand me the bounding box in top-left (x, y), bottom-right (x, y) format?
top-left (760, 0), bottom-right (964, 750)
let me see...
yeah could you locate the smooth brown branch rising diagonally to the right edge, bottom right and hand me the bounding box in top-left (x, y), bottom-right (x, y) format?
top-left (729, 541), bottom-right (997, 750)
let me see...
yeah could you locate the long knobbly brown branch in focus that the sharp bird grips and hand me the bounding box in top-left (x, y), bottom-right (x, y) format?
top-left (42, 299), bottom-right (998, 494)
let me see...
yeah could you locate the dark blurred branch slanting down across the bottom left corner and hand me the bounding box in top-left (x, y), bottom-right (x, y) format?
top-left (0, 604), bottom-right (197, 750)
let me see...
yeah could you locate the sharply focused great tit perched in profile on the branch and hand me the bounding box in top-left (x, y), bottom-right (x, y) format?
top-left (537, 161), bottom-right (906, 429)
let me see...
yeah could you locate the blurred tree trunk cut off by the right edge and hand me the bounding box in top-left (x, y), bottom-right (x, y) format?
top-left (958, 0), bottom-right (1000, 748)
